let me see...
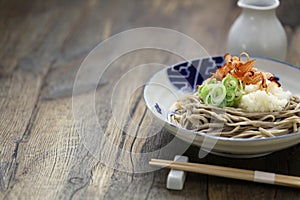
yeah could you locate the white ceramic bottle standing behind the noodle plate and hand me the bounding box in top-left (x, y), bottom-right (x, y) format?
top-left (227, 0), bottom-right (287, 60)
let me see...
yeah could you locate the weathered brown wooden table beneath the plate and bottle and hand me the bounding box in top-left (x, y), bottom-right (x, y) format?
top-left (0, 0), bottom-right (300, 199)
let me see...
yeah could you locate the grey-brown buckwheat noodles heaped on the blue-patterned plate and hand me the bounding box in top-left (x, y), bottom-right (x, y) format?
top-left (168, 93), bottom-right (300, 138)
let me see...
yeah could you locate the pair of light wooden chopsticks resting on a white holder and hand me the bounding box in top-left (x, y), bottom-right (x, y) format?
top-left (149, 159), bottom-right (300, 188)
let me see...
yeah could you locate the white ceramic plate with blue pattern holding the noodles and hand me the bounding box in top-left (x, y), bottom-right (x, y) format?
top-left (144, 56), bottom-right (300, 157)
